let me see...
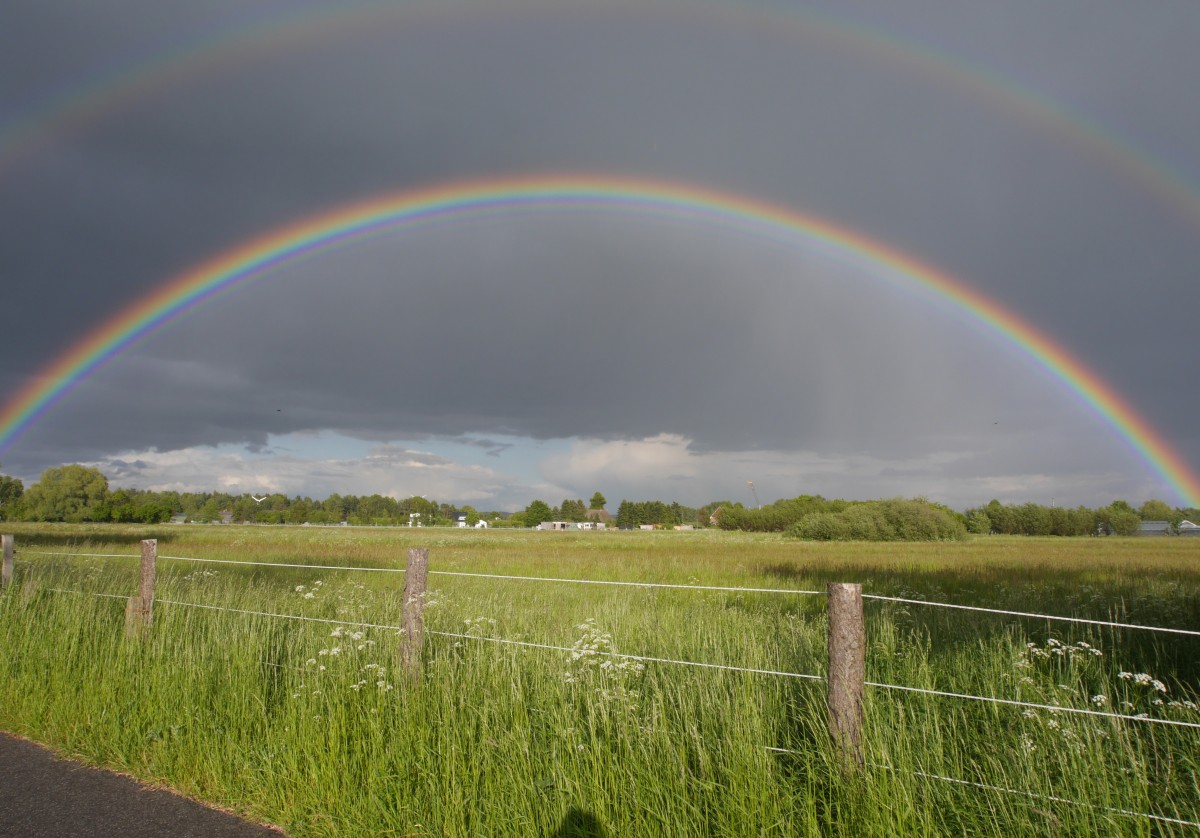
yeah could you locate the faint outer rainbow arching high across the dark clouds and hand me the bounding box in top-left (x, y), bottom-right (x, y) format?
top-left (9, 0), bottom-right (1200, 231)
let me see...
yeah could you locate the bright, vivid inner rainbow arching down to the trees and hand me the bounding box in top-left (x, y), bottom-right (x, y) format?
top-left (0, 174), bottom-right (1200, 507)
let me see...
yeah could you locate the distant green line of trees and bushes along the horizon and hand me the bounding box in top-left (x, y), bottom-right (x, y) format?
top-left (0, 465), bottom-right (1200, 540)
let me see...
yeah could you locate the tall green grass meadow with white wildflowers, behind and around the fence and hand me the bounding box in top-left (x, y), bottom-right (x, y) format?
top-left (0, 525), bottom-right (1200, 837)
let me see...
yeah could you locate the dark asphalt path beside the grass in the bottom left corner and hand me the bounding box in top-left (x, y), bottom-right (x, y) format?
top-left (0, 732), bottom-right (282, 838)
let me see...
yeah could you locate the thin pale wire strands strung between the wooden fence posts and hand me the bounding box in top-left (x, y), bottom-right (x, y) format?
top-left (9, 537), bottom-right (1200, 828)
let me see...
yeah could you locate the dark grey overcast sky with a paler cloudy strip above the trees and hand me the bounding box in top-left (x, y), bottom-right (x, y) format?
top-left (0, 0), bottom-right (1200, 509)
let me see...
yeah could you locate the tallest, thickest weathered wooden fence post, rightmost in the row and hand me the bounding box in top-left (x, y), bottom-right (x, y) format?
top-left (828, 582), bottom-right (866, 770)
